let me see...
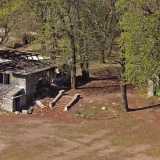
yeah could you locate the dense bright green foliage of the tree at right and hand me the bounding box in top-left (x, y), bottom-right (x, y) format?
top-left (116, 0), bottom-right (160, 85)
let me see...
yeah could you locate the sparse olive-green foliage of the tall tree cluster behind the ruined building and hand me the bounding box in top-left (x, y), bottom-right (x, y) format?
top-left (26, 0), bottom-right (117, 62)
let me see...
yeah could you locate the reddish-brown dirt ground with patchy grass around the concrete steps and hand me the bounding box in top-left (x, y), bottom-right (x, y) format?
top-left (0, 69), bottom-right (160, 160)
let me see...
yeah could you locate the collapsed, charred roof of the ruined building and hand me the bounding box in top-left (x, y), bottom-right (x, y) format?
top-left (0, 50), bottom-right (53, 75)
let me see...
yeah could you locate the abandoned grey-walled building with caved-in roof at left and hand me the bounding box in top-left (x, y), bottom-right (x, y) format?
top-left (0, 50), bottom-right (54, 112)
